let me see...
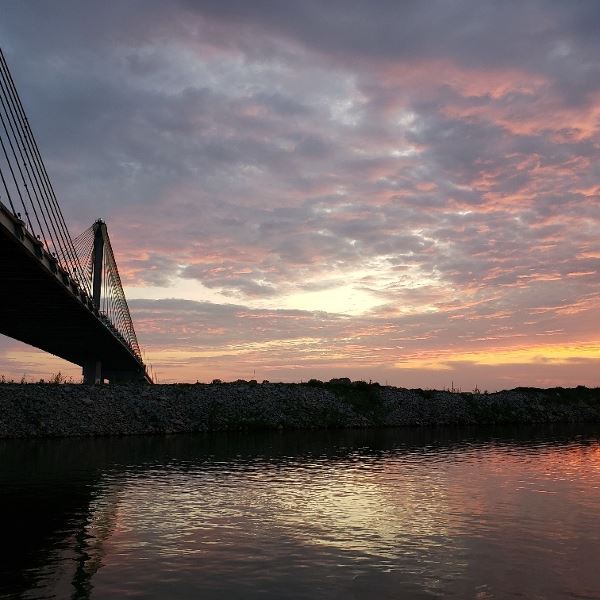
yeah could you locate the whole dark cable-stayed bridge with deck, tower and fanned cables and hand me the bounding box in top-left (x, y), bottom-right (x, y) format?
top-left (0, 49), bottom-right (152, 383)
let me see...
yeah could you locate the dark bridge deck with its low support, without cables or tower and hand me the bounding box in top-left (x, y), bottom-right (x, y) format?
top-left (0, 206), bottom-right (148, 382)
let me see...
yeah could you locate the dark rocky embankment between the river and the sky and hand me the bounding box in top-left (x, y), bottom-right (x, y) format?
top-left (0, 379), bottom-right (600, 438)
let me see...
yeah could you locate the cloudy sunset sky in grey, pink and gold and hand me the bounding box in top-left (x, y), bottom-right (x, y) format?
top-left (0, 0), bottom-right (600, 391)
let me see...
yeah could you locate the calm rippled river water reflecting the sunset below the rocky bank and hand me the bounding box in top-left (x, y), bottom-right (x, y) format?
top-left (0, 428), bottom-right (600, 600)
